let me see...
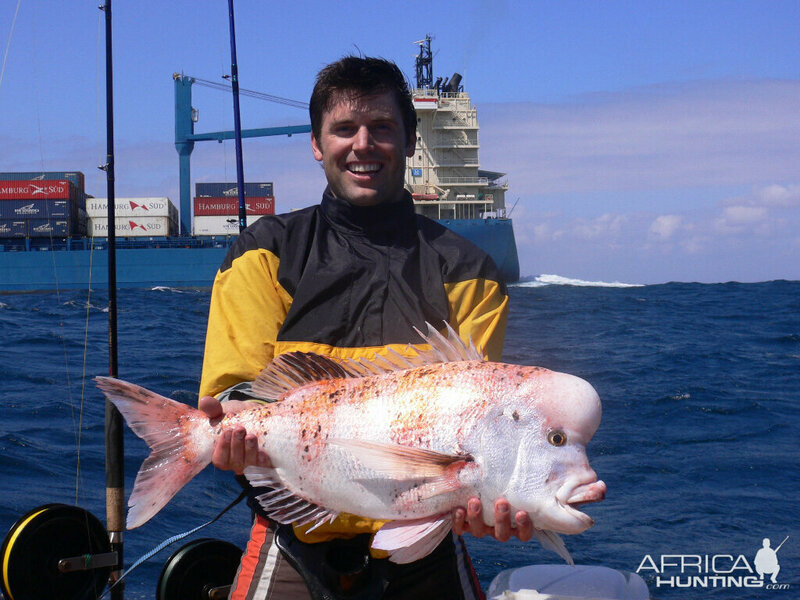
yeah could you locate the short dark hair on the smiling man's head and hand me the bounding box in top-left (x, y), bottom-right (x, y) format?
top-left (308, 56), bottom-right (417, 140)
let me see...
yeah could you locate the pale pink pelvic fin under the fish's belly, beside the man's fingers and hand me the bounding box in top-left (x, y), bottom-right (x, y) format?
top-left (372, 513), bottom-right (453, 564)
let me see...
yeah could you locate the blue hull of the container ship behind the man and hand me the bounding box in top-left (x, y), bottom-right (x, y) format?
top-left (0, 219), bottom-right (519, 292)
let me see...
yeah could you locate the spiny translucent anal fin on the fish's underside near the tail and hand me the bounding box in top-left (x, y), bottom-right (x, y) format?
top-left (244, 467), bottom-right (338, 527)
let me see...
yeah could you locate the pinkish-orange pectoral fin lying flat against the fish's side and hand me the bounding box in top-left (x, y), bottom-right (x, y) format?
top-left (328, 439), bottom-right (473, 479)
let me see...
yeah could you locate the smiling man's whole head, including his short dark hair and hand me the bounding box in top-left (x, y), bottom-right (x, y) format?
top-left (309, 56), bottom-right (416, 206)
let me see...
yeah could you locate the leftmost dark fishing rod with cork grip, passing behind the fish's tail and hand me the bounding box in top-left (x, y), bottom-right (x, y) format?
top-left (99, 0), bottom-right (125, 600)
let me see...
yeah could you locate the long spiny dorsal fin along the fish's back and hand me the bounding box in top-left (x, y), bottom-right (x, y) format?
top-left (253, 321), bottom-right (484, 399)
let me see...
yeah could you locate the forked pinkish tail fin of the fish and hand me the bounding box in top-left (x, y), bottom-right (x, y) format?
top-left (95, 377), bottom-right (214, 529)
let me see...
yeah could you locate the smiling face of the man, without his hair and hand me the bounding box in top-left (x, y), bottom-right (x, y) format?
top-left (311, 92), bottom-right (416, 206)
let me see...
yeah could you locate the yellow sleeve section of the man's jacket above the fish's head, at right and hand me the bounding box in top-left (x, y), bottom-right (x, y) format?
top-left (445, 279), bottom-right (508, 361)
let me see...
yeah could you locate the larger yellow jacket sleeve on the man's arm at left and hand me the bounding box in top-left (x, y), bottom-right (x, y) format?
top-left (200, 249), bottom-right (292, 397)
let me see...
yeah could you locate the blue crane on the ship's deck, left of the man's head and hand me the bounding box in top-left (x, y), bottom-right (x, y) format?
top-left (172, 73), bottom-right (311, 235)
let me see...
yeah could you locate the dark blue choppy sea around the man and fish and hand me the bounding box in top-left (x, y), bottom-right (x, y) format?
top-left (0, 276), bottom-right (800, 600)
